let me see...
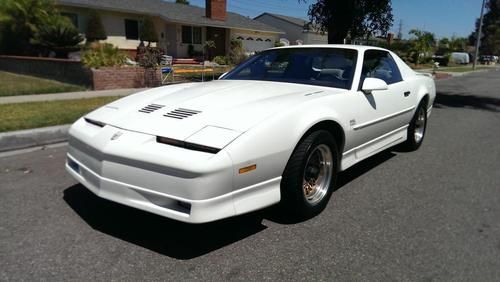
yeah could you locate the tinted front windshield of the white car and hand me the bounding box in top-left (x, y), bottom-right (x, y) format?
top-left (222, 48), bottom-right (357, 89)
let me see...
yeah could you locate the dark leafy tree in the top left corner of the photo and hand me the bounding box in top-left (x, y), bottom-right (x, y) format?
top-left (0, 0), bottom-right (55, 55)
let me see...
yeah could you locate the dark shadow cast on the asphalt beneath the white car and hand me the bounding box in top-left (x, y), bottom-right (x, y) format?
top-left (63, 150), bottom-right (396, 260)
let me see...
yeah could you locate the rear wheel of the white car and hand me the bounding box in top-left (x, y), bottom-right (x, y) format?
top-left (403, 101), bottom-right (427, 151)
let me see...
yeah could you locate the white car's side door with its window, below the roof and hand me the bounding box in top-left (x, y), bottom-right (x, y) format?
top-left (353, 50), bottom-right (415, 158)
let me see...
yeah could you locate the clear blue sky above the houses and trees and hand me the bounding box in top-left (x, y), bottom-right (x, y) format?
top-left (179, 0), bottom-right (482, 38)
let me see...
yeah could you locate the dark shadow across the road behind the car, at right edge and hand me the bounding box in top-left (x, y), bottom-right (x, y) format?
top-left (434, 92), bottom-right (500, 112)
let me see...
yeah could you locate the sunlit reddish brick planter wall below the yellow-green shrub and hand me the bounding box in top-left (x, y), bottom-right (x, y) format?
top-left (92, 67), bottom-right (161, 90)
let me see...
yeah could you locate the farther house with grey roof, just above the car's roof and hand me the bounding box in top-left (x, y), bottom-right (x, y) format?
top-left (254, 13), bottom-right (328, 45)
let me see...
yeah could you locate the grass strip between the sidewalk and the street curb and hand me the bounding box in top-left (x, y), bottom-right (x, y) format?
top-left (0, 97), bottom-right (120, 132)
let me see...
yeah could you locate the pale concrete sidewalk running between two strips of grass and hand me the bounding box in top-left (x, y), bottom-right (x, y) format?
top-left (0, 88), bottom-right (147, 104)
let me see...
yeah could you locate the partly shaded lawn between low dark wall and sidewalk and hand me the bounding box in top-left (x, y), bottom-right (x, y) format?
top-left (0, 71), bottom-right (85, 97)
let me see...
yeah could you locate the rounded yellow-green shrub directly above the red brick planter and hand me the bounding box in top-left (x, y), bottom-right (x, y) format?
top-left (82, 43), bottom-right (127, 68)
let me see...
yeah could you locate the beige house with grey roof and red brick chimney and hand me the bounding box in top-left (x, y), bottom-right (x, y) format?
top-left (57, 0), bottom-right (283, 58)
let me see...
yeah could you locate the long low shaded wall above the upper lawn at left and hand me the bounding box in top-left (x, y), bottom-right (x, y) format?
top-left (0, 56), bottom-right (92, 87)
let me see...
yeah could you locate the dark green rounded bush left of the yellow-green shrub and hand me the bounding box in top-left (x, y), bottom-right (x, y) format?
top-left (30, 14), bottom-right (83, 58)
